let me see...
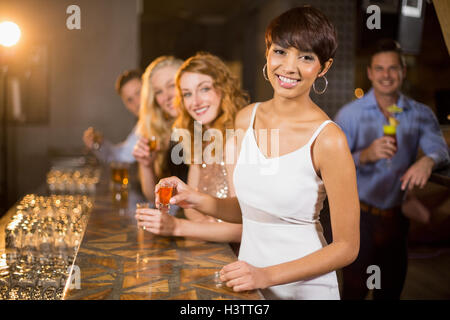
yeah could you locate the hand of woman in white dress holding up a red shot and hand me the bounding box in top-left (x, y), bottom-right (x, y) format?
top-left (155, 177), bottom-right (203, 209)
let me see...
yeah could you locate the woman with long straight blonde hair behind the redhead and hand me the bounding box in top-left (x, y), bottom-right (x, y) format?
top-left (133, 56), bottom-right (187, 201)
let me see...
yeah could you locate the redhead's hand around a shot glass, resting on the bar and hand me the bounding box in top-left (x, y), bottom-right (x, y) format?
top-left (135, 209), bottom-right (178, 236)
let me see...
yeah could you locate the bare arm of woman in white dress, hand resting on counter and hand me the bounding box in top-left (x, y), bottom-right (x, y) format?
top-left (221, 125), bottom-right (359, 291)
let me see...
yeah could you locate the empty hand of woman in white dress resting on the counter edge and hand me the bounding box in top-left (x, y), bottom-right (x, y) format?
top-left (220, 261), bottom-right (270, 292)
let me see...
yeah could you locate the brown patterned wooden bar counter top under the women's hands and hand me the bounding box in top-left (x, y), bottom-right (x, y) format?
top-left (64, 169), bottom-right (263, 300)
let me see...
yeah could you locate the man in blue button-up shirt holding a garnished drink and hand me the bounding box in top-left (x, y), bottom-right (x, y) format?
top-left (335, 40), bottom-right (449, 299)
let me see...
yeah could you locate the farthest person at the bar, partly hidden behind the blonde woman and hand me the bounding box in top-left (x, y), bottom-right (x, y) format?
top-left (83, 70), bottom-right (142, 163)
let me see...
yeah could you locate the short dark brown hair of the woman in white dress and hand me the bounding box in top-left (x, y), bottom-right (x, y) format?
top-left (266, 5), bottom-right (337, 66)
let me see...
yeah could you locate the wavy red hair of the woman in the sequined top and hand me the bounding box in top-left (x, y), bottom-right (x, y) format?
top-left (173, 52), bottom-right (249, 161)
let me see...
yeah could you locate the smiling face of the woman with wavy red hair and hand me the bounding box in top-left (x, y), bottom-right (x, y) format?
top-left (180, 72), bottom-right (222, 125)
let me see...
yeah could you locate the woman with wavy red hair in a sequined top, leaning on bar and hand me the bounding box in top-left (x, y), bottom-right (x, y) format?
top-left (136, 52), bottom-right (248, 248)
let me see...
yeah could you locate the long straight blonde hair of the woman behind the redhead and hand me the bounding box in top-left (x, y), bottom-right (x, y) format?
top-left (137, 56), bottom-right (183, 178)
